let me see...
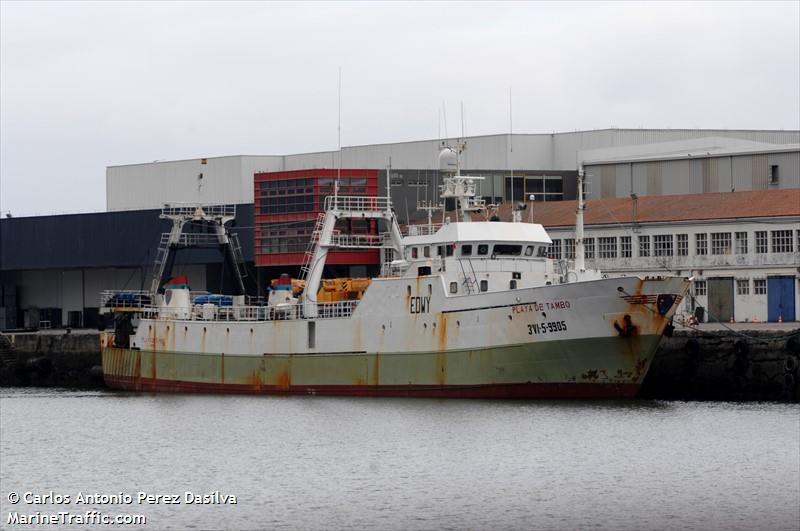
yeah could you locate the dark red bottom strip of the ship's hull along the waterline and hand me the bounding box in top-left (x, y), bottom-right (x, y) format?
top-left (105, 375), bottom-right (639, 399)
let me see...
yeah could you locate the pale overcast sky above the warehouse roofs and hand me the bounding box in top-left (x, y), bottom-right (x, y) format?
top-left (0, 1), bottom-right (800, 215)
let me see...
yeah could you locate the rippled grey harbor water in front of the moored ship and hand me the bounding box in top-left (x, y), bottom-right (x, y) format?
top-left (0, 388), bottom-right (800, 530)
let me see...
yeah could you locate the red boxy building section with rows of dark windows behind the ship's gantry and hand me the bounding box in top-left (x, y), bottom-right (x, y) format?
top-left (254, 169), bottom-right (378, 272)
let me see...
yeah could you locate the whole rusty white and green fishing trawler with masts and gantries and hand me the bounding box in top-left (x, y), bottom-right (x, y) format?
top-left (101, 143), bottom-right (689, 398)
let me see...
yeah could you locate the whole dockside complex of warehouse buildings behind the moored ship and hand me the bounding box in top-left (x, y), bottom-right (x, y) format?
top-left (0, 129), bottom-right (800, 329)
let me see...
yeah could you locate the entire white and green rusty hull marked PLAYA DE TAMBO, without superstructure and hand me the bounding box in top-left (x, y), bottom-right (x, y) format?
top-left (101, 277), bottom-right (688, 398)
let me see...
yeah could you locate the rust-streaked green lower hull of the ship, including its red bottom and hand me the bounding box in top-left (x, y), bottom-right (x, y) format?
top-left (103, 335), bottom-right (660, 399)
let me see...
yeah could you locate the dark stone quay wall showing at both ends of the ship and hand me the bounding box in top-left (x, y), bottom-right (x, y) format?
top-left (0, 329), bottom-right (800, 402)
